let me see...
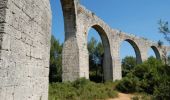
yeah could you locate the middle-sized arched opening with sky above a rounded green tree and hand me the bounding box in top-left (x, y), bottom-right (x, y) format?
top-left (120, 39), bottom-right (142, 77)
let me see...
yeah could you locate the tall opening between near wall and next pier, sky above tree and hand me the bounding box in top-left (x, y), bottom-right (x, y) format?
top-left (49, 0), bottom-right (64, 83)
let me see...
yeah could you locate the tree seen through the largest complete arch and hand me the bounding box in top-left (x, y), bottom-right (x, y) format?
top-left (88, 37), bottom-right (104, 82)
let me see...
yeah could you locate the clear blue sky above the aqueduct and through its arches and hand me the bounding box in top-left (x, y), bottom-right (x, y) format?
top-left (50, 0), bottom-right (170, 57)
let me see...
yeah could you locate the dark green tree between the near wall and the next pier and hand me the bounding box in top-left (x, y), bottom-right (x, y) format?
top-left (49, 35), bottom-right (62, 82)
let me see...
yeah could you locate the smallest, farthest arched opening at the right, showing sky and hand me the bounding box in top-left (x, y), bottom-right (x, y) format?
top-left (148, 46), bottom-right (161, 60)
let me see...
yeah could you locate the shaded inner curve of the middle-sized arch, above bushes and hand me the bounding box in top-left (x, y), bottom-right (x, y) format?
top-left (121, 39), bottom-right (142, 64)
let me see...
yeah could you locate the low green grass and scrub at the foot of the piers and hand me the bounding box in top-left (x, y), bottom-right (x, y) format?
top-left (49, 78), bottom-right (117, 100)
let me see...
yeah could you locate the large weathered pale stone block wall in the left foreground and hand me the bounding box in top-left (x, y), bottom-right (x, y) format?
top-left (0, 0), bottom-right (51, 100)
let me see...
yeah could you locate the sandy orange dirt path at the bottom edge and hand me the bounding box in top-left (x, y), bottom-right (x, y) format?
top-left (108, 93), bottom-right (133, 100)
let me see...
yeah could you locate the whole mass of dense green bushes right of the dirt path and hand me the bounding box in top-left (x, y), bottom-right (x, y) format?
top-left (116, 57), bottom-right (170, 100)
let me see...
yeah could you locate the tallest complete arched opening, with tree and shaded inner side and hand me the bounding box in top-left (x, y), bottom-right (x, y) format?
top-left (87, 25), bottom-right (112, 82)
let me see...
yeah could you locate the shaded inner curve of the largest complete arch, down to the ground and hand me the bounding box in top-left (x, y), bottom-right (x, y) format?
top-left (86, 24), bottom-right (113, 81)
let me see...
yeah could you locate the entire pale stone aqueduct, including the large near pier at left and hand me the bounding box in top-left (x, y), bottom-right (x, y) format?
top-left (0, 0), bottom-right (170, 100)
